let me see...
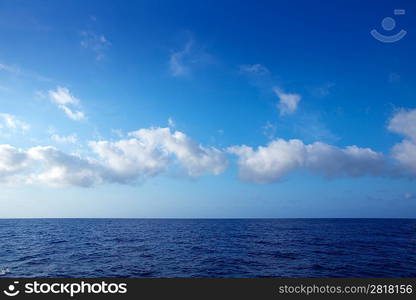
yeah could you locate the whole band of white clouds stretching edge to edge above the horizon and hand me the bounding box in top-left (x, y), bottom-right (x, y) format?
top-left (0, 109), bottom-right (416, 187)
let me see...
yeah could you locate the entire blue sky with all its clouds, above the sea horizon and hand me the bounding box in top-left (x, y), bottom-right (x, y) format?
top-left (0, 1), bottom-right (416, 218)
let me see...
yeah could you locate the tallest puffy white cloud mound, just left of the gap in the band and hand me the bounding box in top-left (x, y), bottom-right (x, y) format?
top-left (90, 128), bottom-right (227, 181)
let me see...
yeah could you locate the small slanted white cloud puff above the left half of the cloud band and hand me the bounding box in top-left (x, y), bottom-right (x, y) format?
top-left (48, 86), bottom-right (85, 121)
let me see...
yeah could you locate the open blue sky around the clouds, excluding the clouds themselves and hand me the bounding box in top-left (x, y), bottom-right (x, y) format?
top-left (0, 1), bottom-right (416, 218)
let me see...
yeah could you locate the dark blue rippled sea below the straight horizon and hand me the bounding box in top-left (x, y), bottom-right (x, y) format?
top-left (0, 219), bottom-right (416, 277)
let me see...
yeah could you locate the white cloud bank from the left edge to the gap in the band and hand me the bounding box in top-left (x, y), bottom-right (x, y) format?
top-left (0, 128), bottom-right (227, 187)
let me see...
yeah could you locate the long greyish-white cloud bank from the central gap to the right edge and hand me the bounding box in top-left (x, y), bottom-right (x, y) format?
top-left (228, 109), bottom-right (416, 183)
